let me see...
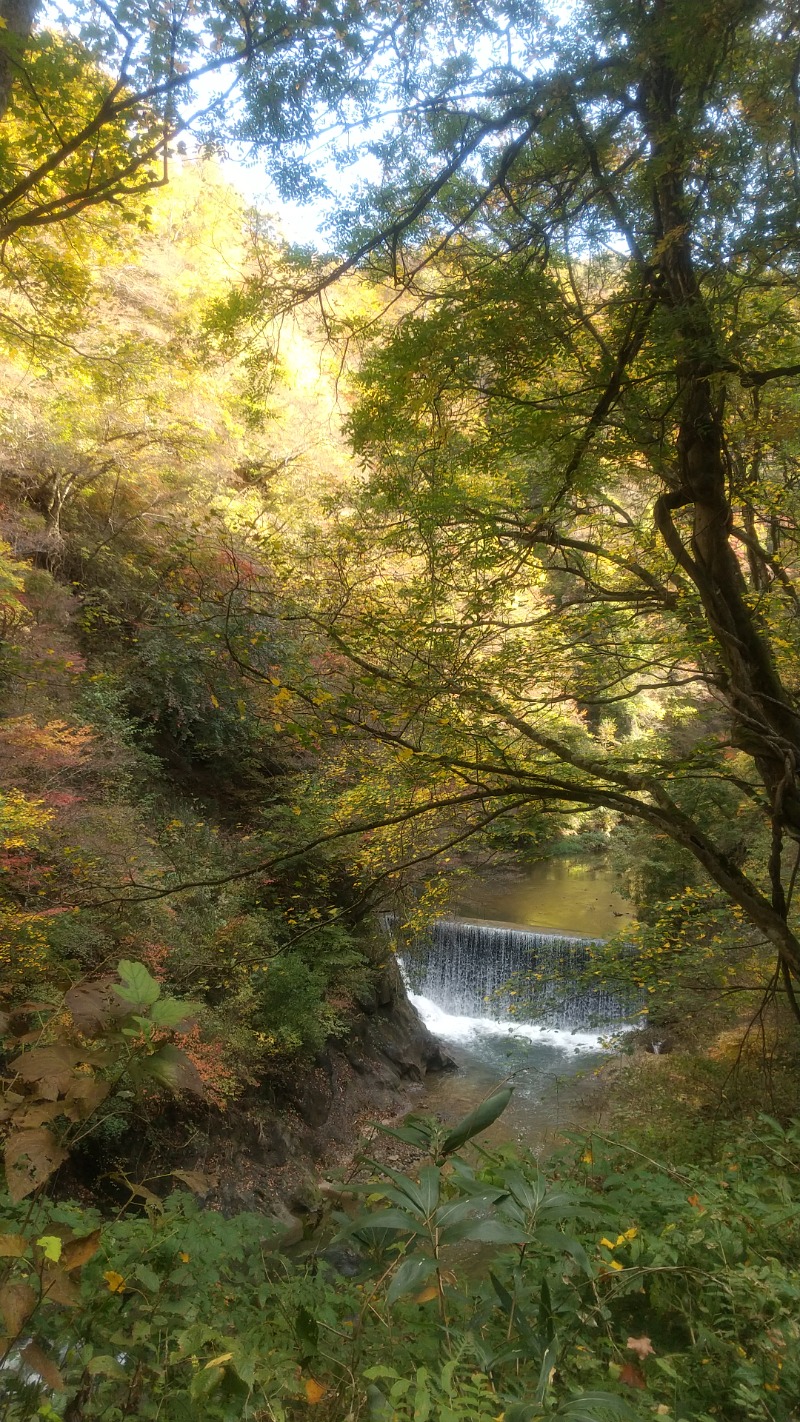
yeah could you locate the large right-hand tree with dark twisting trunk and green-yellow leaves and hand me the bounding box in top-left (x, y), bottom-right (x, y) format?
top-left (233, 0), bottom-right (800, 1023)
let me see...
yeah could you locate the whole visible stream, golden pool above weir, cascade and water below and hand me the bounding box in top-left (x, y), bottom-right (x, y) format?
top-left (404, 859), bottom-right (634, 1149)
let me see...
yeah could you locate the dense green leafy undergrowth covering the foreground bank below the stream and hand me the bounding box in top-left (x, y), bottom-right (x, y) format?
top-left (0, 1092), bottom-right (800, 1422)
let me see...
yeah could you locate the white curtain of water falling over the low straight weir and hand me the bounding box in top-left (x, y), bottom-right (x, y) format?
top-left (404, 919), bottom-right (634, 1031)
